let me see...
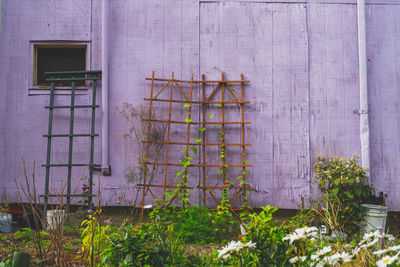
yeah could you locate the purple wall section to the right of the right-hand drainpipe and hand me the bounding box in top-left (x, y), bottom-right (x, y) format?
top-left (366, 3), bottom-right (400, 210)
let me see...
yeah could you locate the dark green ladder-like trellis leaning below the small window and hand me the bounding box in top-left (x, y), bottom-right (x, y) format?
top-left (41, 70), bottom-right (101, 216)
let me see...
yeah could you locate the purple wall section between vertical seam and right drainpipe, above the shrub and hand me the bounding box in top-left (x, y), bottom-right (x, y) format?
top-left (308, 4), bottom-right (361, 200)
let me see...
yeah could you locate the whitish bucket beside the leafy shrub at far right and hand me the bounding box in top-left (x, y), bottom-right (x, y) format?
top-left (362, 204), bottom-right (387, 233)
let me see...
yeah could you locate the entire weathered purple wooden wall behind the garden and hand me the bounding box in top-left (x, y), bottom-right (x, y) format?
top-left (0, 0), bottom-right (400, 210)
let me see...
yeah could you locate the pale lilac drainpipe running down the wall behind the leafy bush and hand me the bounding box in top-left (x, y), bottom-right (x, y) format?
top-left (357, 0), bottom-right (370, 174)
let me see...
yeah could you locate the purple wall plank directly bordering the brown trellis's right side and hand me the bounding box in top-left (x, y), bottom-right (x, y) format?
top-left (250, 3), bottom-right (274, 207)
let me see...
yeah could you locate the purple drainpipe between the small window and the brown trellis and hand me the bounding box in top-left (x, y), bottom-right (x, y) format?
top-left (101, 0), bottom-right (111, 176)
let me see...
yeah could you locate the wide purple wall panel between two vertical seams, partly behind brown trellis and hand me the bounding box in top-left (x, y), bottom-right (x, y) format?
top-left (200, 2), bottom-right (310, 208)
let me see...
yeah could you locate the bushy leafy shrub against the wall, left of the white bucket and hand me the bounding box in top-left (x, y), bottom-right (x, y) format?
top-left (314, 155), bottom-right (374, 236)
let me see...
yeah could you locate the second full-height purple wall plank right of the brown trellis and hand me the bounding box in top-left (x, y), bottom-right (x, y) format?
top-left (272, 4), bottom-right (293, 207)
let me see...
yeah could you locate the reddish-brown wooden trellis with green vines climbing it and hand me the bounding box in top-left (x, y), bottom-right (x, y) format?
top-left (138, 71), bottom-right (252, 220)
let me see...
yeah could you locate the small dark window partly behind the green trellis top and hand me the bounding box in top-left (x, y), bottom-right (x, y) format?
top-left (33, 45), bottom-right (86, 86)
